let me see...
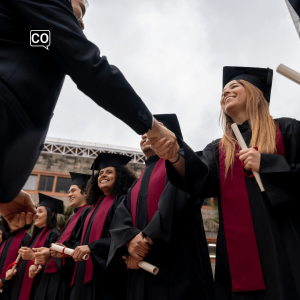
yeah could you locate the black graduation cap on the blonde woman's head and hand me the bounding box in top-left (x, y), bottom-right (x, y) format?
top-left (223, 67), bottom-right (273, 102)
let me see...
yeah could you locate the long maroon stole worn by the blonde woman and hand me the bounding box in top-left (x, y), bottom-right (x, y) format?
top-left (219, 126), bottom-right (285, 292)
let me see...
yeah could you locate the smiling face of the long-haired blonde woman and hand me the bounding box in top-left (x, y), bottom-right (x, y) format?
top-left (221, 80), bottom-right (247, 118)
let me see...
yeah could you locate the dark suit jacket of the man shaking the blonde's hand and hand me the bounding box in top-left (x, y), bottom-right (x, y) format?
top-left (0, 0), bottom-right (152, 202)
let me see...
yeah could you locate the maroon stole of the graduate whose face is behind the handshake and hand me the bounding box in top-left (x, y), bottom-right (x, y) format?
top-left (131, 158), bottom-right (167, 227)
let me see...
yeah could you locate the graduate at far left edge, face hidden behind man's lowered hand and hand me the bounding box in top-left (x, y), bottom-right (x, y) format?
top-left (0, 217), bottom-right (31, 300)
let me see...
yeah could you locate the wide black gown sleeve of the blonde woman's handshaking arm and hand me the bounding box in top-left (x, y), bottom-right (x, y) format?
top-left (166, 137), bottom-right (220, 199)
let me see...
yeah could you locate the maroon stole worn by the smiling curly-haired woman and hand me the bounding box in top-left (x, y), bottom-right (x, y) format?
top-left (71, 196), bottom-right (115, 286)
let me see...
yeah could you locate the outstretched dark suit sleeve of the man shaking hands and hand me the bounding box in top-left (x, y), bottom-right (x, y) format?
top-left (10, 0), bottom-right (153, 134)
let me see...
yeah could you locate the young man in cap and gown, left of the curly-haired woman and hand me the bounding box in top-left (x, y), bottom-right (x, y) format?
top-left (35, 172), bottom-right (90, 300)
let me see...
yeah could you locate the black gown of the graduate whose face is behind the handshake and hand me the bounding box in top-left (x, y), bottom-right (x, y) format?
top-left (109, 155), bottom-right (213, 300)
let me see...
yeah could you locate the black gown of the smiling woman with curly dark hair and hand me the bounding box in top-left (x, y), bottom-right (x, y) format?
top-left (70, 196), bottom-right (127, 300)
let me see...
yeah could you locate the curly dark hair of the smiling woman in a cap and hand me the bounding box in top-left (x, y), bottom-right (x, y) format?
top-left (86, 166), bottom-right (137, 205)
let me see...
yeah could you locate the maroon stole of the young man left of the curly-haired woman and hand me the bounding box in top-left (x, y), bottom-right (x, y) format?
top-left (45, 204), bottom-right (89, 273)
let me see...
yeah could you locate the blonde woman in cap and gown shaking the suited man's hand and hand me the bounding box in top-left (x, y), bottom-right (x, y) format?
top-left (152, 67), bottom-right (300, 300)
